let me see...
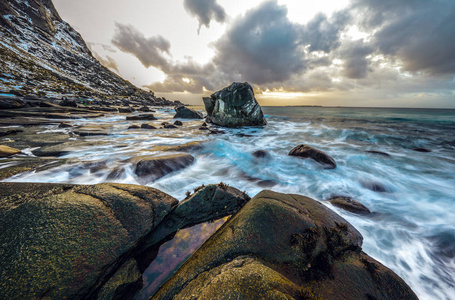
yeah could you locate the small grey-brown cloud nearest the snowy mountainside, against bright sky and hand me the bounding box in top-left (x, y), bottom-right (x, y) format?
top-left (112, 23), bottom-right (171, 70)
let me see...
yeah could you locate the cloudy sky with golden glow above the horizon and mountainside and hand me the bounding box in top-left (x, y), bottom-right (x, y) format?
top-left (54, 0), bottom-right (455, 108)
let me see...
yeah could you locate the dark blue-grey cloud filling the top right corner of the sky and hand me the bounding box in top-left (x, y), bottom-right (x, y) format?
top-left (353, 0), bottom-right (455, 75)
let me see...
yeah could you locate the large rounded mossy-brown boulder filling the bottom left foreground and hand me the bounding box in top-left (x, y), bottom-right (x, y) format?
top-left (0, 182), bottom-right (178, 299)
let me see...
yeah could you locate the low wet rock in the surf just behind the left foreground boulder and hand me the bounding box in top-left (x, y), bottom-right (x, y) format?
top-left (132, 154), bottom-right (194, 183)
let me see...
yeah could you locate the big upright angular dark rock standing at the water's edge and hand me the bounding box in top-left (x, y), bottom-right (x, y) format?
top-left (203, 82), bottom-right (267, 127)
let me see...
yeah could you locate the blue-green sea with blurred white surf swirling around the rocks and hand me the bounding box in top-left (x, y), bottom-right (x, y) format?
top-left (1, 107), bottom-right (455, 299)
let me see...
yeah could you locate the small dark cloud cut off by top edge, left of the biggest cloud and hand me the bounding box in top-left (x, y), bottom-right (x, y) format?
top-left (183, 0), bottom-right (226, 33)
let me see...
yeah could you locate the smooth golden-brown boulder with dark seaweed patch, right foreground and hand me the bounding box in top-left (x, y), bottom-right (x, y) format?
top-left (151, 191), bottom-right (417, 299)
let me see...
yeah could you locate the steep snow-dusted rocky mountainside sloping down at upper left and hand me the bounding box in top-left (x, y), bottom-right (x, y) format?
top-left (0, 0), bottom-right (154, 99)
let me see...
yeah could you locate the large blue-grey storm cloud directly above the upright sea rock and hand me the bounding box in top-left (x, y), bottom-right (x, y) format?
top-left (214, 1), bottom-right (305, 84)
